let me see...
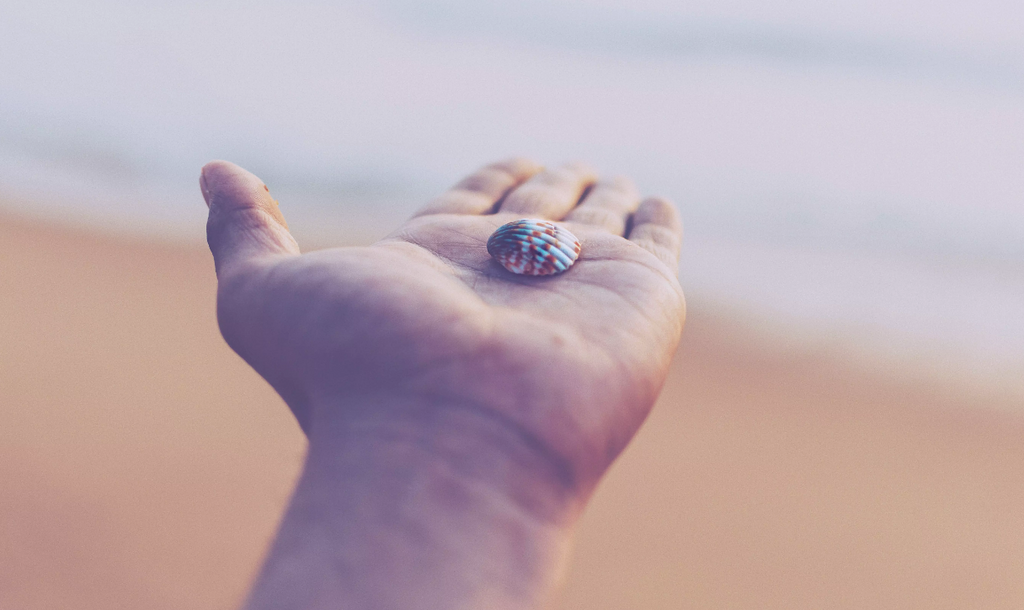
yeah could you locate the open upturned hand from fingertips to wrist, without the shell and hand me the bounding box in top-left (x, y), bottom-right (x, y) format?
top-left (201, 160), bottom-right (685, 610)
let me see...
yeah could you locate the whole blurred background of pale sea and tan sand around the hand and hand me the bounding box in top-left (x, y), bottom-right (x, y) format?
top-left (0, 0), bottom-right (1024, 608)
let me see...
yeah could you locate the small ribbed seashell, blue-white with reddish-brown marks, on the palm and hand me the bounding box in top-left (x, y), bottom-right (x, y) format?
top-left (487, 218), bottom-right (580, 275)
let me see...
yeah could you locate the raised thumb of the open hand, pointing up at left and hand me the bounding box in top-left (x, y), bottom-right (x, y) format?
top-left (199, 161), bottom-right (299, 274)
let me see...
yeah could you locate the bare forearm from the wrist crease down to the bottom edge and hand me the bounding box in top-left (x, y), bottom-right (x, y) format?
top-left (238, 397), bottom-right (577, 610)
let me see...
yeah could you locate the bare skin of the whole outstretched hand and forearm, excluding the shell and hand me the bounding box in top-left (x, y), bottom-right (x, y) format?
top-left (201, 160), bottom-right (685, 610)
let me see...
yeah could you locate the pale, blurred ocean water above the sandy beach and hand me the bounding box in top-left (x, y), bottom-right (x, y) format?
top-left (0, 0), bottom-right (1024, 390)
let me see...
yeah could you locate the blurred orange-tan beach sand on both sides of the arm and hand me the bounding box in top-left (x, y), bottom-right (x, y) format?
top-left (0, 212), bottom-right (1024, 610)
